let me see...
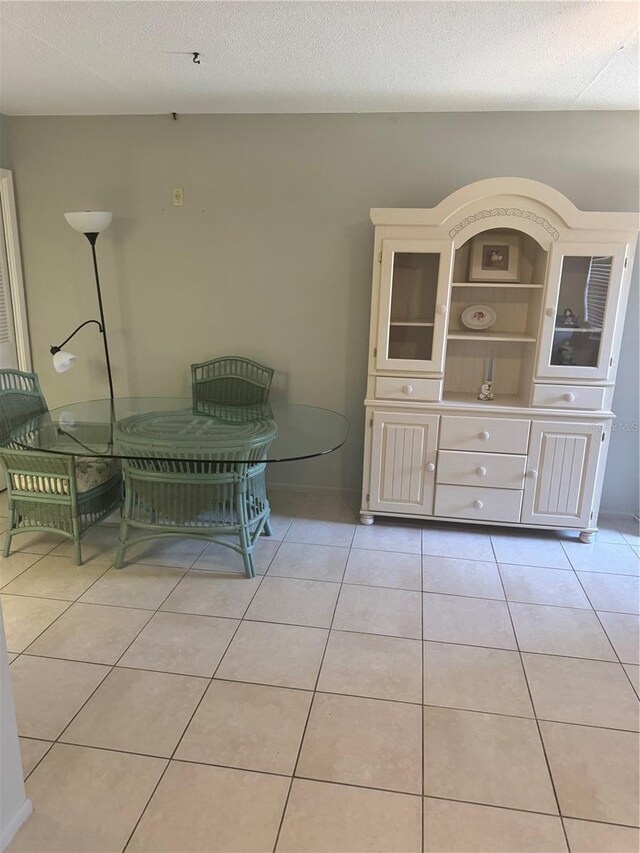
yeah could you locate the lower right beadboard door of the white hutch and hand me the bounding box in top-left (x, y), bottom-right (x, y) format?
top-left (522, 421), bottom-right (604, 527)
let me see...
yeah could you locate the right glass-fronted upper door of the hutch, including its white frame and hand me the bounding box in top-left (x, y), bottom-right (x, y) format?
top-left (538, 243), bottom-right (626, 379)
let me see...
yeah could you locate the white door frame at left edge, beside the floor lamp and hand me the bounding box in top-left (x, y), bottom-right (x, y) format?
top-left (0, 169), bottom-right (31, 371)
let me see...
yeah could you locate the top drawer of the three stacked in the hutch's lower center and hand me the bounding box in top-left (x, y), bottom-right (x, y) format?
top-left (439, 415), bottom-right (530, 453)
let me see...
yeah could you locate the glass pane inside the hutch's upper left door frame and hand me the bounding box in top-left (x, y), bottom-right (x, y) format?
top-left (388, 252), bottom-right (440, 361)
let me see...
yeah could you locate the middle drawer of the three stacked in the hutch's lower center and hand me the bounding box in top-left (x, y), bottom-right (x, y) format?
top-left (436, 450), bottom-right (527, 489)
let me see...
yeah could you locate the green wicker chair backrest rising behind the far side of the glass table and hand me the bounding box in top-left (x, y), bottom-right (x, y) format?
top-left (191, 356), bottom-right (274, 405)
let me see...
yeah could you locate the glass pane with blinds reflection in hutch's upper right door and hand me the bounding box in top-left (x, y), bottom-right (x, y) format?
top-left (551, 255), bottom-right (613, 367)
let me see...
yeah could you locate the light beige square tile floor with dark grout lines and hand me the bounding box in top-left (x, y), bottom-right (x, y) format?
top-left (0, 490), bottom-right (640, 853)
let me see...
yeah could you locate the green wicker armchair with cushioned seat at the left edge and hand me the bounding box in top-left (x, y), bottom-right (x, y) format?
top-left (0, 370), bottom-right (122, 566)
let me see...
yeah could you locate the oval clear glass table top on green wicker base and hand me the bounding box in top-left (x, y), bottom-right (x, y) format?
top-left (5, 397), bottom-right (349, 462)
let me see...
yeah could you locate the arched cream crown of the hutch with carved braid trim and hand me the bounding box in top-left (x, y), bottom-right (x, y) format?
top-left (371, 178), bottom-right (639, 235)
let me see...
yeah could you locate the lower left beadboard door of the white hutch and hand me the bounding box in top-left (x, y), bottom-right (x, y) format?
top-left (369, 412), bottom-right (438, 515)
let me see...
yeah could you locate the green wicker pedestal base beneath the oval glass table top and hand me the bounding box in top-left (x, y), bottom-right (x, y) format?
top-left (116, 423), bottom-right (277, 578)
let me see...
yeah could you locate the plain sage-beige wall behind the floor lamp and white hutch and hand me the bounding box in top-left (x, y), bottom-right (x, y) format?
top-left (9, 112), bottom-right (638, 512)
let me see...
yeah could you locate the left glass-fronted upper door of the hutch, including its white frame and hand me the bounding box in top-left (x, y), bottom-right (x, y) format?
top-left (376, 240), bottom-right (453, 373)
